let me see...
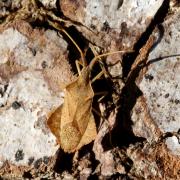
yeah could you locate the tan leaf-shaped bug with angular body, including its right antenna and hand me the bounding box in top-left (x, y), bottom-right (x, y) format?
top-left (47, 42), bottom-right (131, 153)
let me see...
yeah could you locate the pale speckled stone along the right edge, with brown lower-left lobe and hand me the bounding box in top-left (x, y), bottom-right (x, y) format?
top-left (132, 6), bottom-right (180, 155)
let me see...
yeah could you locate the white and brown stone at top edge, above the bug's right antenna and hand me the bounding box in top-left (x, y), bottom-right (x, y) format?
top-left (60, 0), bottom-right (163, 50)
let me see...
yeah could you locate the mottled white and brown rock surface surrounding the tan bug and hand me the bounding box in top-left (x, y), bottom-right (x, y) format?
top-left (0, 0), bottom-right (180, 179)
